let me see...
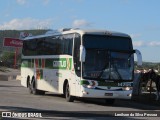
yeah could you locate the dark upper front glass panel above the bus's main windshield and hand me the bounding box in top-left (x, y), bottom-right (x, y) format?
top-left (83, 35), bottom-right (133, 50)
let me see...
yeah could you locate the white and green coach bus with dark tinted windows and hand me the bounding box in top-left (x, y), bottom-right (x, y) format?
top-left (21, 29), bottom-right (142, 104)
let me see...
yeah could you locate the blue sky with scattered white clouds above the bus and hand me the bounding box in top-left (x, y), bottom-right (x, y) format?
top-left (0, 0), bottom-right (160, 62)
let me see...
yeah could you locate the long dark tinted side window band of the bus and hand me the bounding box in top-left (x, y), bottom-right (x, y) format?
top-left (23, 34), bottom-right (74, 56)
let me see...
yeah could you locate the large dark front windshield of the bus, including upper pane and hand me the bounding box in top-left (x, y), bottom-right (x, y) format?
top-left (83, 36), bottom-right (134, 81)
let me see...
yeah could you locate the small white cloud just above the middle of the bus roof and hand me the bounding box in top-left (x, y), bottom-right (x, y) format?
top-left (72, 19), bottom-right (91, 27)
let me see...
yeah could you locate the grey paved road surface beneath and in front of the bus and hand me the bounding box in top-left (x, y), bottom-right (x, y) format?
top-left (0, 80), bottom-right (160, 120)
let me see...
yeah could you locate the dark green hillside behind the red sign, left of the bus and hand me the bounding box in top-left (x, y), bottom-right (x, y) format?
top-left (0, 29), bottom-right (48, 67)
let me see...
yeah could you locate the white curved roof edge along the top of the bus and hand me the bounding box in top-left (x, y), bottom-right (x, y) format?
top-left (23, 29), bottom-right (130, 40)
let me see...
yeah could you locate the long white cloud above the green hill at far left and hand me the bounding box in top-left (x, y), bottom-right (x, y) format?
top-left (0, 18), bottom-right (53, 30)
